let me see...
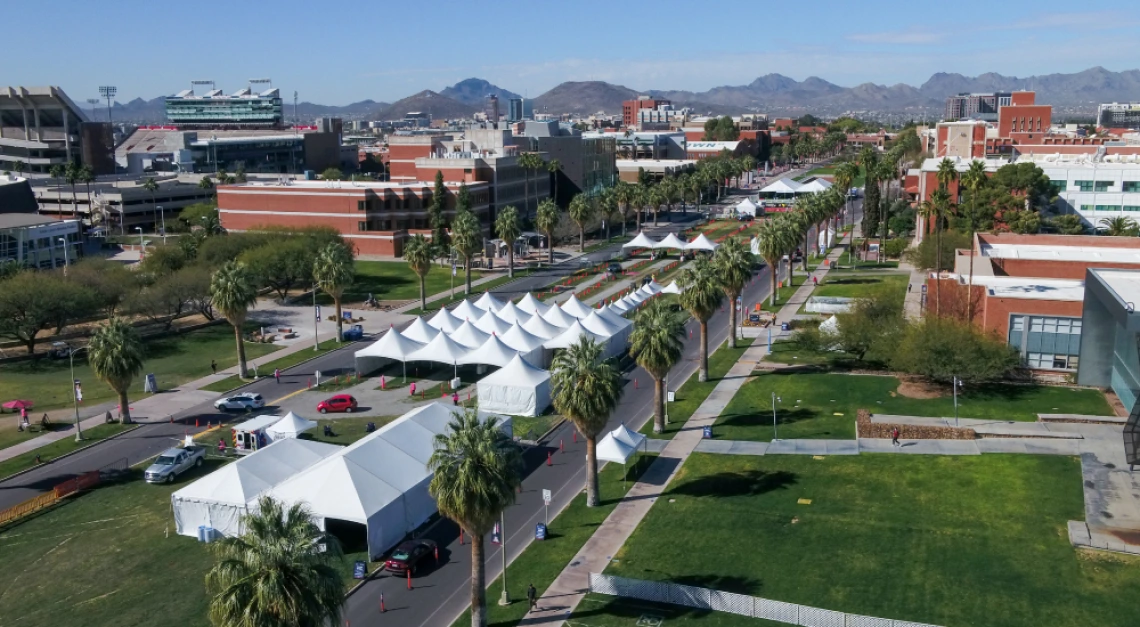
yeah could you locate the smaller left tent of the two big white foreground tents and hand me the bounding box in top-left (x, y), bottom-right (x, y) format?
top-left (170, 439), bottom-right (342, 537)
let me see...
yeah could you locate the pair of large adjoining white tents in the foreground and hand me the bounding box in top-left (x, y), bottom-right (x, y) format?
top-left (171, 404), bottom-right (511, 559)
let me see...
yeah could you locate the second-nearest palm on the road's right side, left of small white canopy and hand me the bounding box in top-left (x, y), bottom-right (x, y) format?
top-left (551, 335), bottom-right (622, 507)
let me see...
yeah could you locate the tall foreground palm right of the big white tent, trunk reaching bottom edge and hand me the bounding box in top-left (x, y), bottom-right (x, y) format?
top-left (428, 409), bottom-right (523, 627)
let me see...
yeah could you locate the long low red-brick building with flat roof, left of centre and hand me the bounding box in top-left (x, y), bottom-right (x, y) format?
top-left (218, 177), bottom-right (492, 257)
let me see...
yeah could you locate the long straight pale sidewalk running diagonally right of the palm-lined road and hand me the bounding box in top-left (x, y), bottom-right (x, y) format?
top-left (523, 232), bottom-right (842, 626)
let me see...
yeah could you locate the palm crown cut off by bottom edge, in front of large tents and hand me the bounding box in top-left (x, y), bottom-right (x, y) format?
top-left (206, 497), bottom-right (344, 627)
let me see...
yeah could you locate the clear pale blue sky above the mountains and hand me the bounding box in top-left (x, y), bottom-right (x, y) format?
top-left (8, 0), bottom-right (1140, 105)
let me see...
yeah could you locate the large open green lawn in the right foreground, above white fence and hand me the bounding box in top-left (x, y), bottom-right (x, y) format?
top-left (601, 454), bottom-right (1140, 627)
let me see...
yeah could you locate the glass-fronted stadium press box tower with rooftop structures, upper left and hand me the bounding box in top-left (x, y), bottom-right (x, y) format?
top-left (163, 83), bottom-right (284, 129)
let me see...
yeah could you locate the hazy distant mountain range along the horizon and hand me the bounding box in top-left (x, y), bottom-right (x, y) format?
top-left (82, 66), bottom-right (1140, 122)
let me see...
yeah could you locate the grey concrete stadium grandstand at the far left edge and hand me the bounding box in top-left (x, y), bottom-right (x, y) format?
top-left (0, 87), bottom-right (115, 174)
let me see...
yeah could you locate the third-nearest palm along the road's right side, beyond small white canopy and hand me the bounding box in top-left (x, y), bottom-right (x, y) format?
top-left (629, 299), bottom-right (685, 433)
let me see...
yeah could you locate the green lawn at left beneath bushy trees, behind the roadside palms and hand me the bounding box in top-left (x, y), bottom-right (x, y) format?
top-left (0, 324), bottom-right (280, 414)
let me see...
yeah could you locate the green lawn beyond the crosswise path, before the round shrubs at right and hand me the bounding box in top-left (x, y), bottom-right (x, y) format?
top-left (715, 371), bottom-right (1113, 441)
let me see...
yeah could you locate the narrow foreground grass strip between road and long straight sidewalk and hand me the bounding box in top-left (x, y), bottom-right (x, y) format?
top-left (451, 454), bottom-right (656, 627)
